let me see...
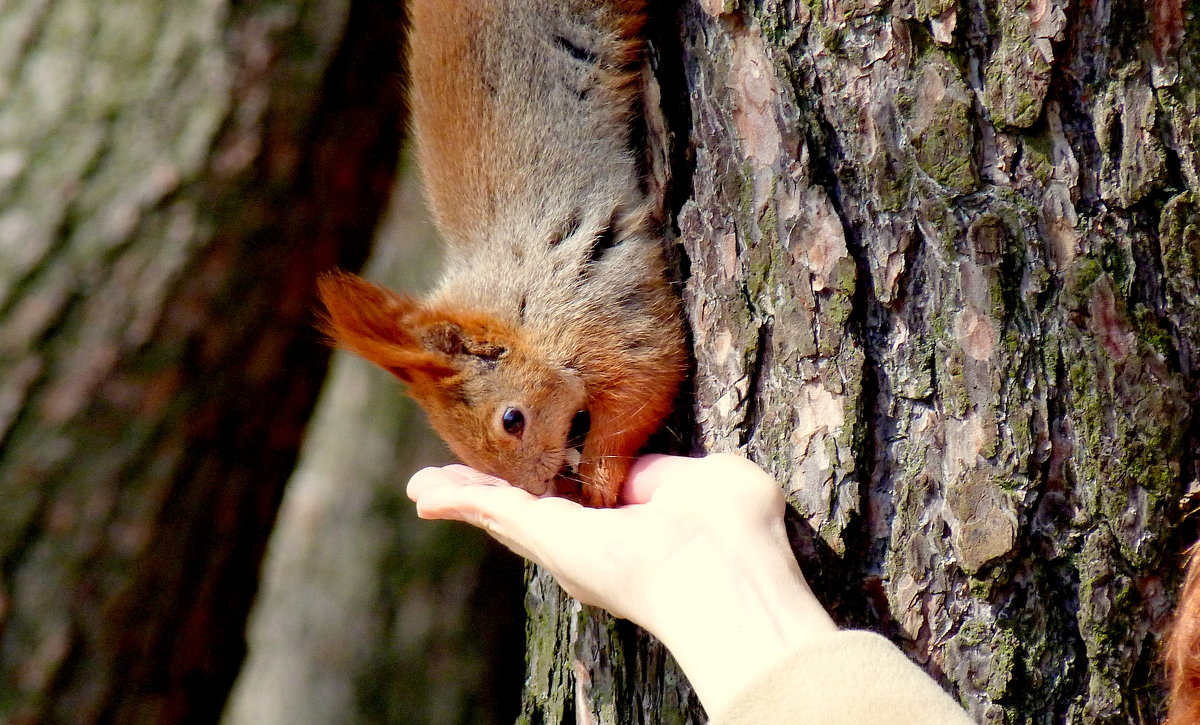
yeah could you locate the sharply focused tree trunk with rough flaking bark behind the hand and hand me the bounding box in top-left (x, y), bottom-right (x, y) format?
top-left (522, 0), bottom-right (1200, 723)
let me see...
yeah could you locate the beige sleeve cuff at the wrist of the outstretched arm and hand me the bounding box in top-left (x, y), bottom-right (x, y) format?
top-left (710, 630), bottom-right (971, 725)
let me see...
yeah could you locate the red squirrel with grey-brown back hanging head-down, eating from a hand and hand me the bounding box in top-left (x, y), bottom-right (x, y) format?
top-left (318, 0), bottom-right (686, 507)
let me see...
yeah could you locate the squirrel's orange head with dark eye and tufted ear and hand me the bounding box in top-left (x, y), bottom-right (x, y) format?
top-left (318, 274), bottom-right (588, 495)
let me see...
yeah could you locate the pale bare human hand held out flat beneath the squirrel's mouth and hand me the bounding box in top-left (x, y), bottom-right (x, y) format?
top-left (408, 455), bottom-right (836, 712)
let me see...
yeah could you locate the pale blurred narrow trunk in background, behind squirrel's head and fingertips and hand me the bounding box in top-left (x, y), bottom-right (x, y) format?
top-left (223, 158), bottom-right (524, 725)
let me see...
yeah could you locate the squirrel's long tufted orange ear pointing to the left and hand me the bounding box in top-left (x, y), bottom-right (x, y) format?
top-left (317, 272), bottom-right (457, 383)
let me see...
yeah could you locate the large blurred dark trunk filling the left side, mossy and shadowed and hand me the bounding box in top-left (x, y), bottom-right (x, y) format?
top-left (0, 0), bottom-right (402, 724)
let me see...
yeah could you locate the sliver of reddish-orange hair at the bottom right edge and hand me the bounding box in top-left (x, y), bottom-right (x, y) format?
top-left (1165, 544), bottom-right (1200, 725)
